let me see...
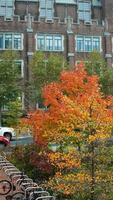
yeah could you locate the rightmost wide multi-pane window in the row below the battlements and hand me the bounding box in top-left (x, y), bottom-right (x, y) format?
top-left (76, 35), bottom-right (101, 52)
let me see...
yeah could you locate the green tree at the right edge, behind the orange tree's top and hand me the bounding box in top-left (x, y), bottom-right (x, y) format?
top-left (85, 52), bottom-right (113, 95)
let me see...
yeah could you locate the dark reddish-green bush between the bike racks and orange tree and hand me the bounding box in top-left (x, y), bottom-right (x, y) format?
top-left (8, 144), bottom-right (55, 183)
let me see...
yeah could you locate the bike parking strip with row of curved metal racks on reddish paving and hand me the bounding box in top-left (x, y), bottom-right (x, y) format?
top-left (0, 156), bottom-right (55, 200)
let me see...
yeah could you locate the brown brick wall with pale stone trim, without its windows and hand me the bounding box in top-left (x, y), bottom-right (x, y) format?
top-left (0, 0), bottom-right (113, 109)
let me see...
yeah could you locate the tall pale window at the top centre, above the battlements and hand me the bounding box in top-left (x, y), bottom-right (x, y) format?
top-left (40, 0), bottom-right (54, 20)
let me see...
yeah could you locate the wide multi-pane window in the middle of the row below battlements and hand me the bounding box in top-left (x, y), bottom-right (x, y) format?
top-left (36, 34), bottom-right (64, 51)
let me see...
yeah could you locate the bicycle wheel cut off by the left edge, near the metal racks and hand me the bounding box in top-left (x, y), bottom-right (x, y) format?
top-left (0, 180), bottom-right (12, 195)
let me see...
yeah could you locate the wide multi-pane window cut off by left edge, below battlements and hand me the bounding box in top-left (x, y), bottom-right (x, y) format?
top-left (0, 33), bottom-right (23, 50)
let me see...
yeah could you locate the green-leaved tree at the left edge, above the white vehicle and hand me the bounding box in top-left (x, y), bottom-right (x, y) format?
top-left (0, 51), bottom-right (19, 126)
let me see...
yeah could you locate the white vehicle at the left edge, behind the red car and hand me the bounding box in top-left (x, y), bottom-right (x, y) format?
top-left (0, 127), bottom-right (16, 141)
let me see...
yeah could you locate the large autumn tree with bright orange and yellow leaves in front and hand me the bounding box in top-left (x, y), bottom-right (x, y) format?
top-left (25, 64), bottom-right (113, 200)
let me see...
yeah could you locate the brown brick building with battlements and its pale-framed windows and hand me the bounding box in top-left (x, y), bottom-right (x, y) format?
top-left (0, 0), bottom-right (113, 109)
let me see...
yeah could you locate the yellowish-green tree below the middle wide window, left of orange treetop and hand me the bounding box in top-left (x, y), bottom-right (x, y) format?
top-left (29, 52), bottom-right (68, 108)
